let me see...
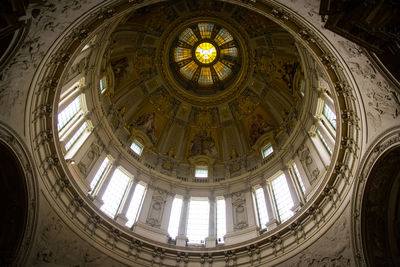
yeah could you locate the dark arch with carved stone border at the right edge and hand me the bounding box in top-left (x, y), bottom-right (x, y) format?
top-left (352, 130), bottom-right (400, 266)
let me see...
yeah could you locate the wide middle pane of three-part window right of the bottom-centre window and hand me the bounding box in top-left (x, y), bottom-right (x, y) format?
top-left (271, 174), bottom-right (293, 223)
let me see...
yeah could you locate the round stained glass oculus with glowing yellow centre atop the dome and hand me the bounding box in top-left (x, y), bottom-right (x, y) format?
top-left (171, 22), bottom-right (239, 88)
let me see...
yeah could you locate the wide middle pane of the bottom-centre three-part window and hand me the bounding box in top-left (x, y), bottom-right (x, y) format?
top-left (187, 198), bottom-right (210, 244)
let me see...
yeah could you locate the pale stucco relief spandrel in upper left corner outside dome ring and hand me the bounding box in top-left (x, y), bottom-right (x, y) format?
top-left (0, 0), bottom-right (91, 118)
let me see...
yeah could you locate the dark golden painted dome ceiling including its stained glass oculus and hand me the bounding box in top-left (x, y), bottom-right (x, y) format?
top-left (101, 1), bottom-right (304, 169)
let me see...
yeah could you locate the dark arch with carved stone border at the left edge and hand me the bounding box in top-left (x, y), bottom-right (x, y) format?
top-left (0, 124), bottom-right (38, 266)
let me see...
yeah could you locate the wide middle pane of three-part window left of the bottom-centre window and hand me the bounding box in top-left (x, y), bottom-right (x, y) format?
top-left (101, 169), bottom-right (130, 217)
